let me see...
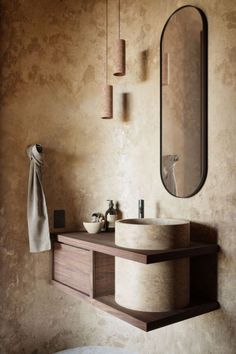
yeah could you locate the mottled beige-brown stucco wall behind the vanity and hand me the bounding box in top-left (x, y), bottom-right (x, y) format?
top-left (0, 0), bottom-right (236, 354)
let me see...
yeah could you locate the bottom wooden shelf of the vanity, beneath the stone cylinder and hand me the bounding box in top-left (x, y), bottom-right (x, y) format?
top-left (53, 281), bottom-right (220, 332)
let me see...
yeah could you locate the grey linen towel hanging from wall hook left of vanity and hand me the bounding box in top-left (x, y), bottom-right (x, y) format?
top-left (27, 144), bottom-right (51, 252)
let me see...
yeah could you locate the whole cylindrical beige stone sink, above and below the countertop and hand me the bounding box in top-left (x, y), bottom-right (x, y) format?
top-left (115, 218), bottom-right (190, 312)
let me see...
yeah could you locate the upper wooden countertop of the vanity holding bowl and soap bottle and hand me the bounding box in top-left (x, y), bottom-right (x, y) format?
top-left (56, 232), bottom-right (218, 264)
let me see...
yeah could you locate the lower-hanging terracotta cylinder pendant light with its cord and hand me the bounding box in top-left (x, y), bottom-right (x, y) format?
top-left (102, 0), bottom-right (113, 119)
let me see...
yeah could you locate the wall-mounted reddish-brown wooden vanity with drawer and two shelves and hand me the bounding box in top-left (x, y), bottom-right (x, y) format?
top-left (53, 232), bottom-right (220, 331)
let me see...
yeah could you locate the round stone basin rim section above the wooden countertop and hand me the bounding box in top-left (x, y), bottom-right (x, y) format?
top-left (115, 218), bottom-right (190, 250)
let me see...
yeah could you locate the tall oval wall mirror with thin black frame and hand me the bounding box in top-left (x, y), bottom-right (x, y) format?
top-left (160, 6), bottom-right (207, 198)
